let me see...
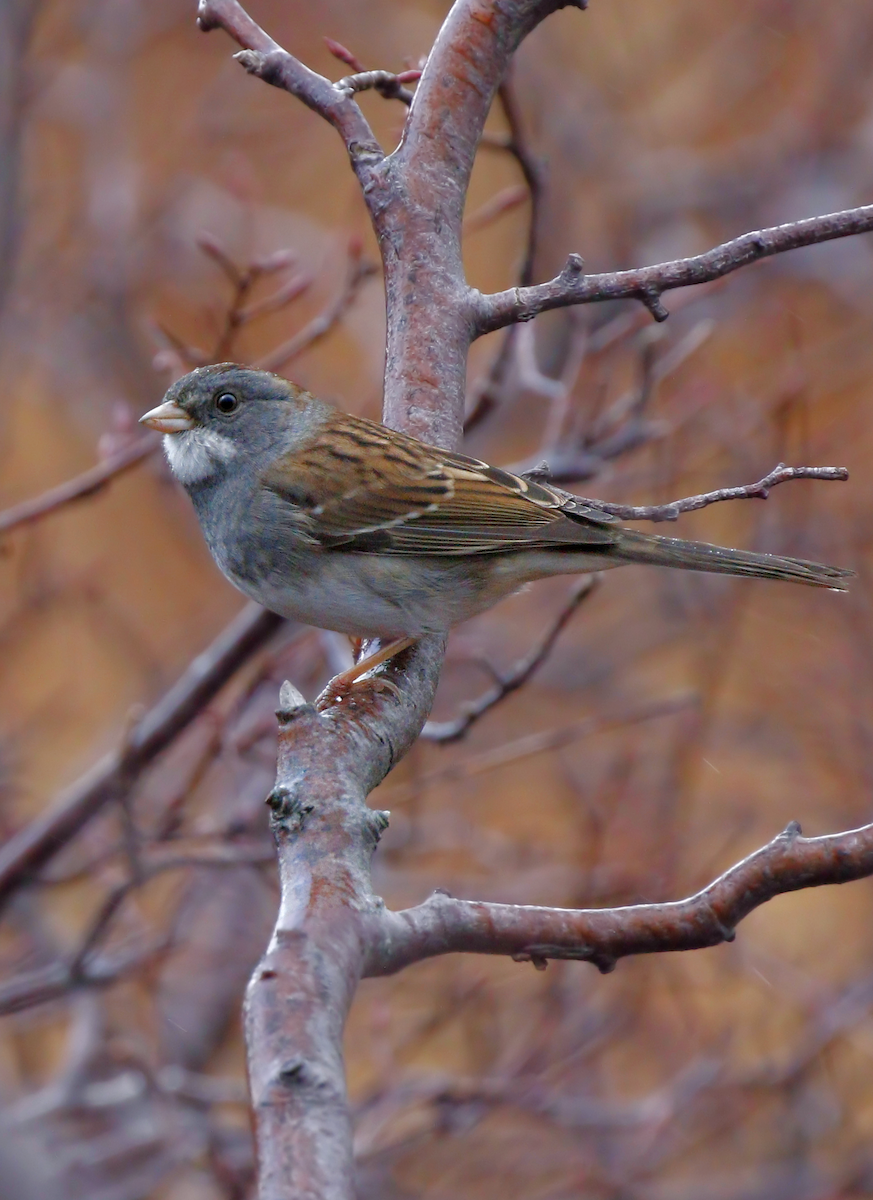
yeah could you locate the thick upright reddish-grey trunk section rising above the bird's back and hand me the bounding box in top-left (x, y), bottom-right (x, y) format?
top-left (381, 0), bottom-right (583, 449)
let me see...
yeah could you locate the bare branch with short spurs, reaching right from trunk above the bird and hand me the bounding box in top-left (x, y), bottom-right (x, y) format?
top-left (476, 204), bottom-right (873, 336)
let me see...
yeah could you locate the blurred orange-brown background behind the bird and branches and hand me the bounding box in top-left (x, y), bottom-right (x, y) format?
top-left (0, 0), bottom-right (873, 1200)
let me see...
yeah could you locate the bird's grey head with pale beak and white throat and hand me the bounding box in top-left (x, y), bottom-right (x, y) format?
top-left (139, 362), bottom-right (326, 490)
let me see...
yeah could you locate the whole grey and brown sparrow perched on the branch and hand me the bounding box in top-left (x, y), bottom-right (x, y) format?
top-left (140, 362), bottom-right (853, 683)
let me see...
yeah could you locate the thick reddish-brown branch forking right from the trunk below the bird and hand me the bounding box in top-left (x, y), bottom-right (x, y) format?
top-left (365, 822), bottom-right (873, 976)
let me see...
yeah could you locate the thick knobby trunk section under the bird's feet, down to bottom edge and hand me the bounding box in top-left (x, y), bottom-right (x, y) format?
top-left (246, 637), bottom-right (445, 1200)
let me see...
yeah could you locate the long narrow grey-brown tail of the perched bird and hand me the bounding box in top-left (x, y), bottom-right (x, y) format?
top-left (615, 529), bottom-right (855, 592)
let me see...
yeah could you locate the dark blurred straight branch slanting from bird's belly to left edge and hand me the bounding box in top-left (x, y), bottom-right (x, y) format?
top-left (0, 604), bottom-right (283, 901)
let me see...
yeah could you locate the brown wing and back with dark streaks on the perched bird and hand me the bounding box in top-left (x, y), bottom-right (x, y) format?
top-left (263, 413), bottom-right (618, 554)
